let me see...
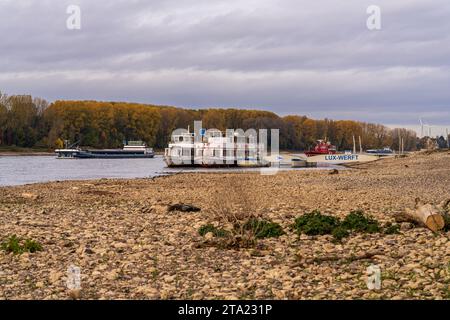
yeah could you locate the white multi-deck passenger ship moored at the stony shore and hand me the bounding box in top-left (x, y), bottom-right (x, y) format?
top-left (164, 130), bottom-right (270, 167)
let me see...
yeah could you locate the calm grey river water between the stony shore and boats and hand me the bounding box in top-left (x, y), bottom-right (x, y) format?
top-left (0, 155), bottom-right (337, 186)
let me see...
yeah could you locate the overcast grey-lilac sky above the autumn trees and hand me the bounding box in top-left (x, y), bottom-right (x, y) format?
top-left (0, 0), bottom-right (450, 133)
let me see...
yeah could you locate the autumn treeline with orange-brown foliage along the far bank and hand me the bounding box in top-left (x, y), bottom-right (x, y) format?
top-left (0, 93), bottom-right (418, 150)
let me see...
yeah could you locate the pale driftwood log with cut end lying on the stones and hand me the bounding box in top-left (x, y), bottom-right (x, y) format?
top-left (395, 199), bottom-right (450, 232)
